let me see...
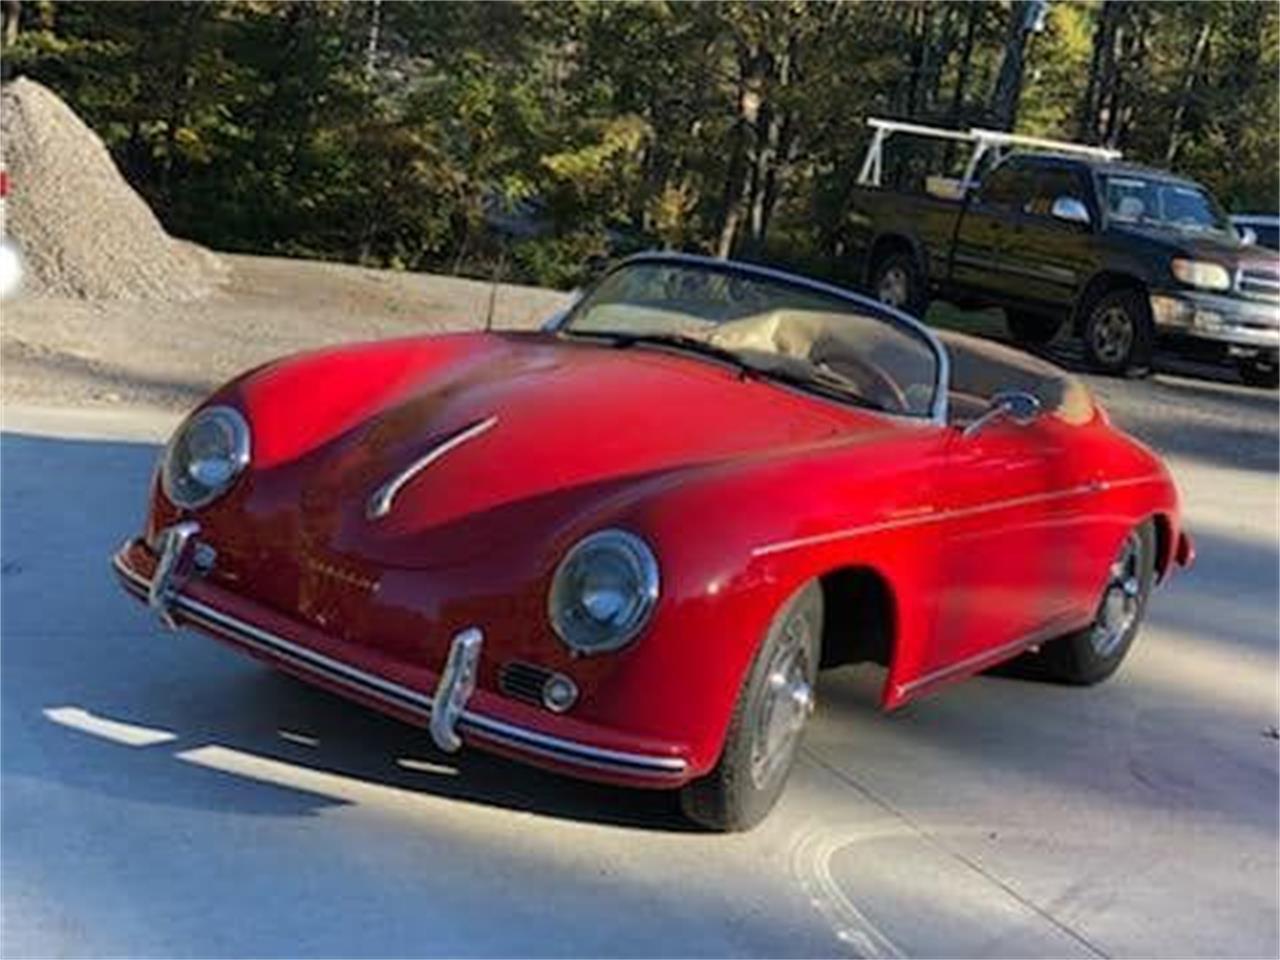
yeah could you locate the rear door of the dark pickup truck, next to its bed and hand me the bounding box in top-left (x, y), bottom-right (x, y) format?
top-left (951, 156), bottom-right (1036, 302)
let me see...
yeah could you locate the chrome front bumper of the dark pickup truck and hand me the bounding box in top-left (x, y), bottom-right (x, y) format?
top-left (1151, 291), bottom-right (1280, 355)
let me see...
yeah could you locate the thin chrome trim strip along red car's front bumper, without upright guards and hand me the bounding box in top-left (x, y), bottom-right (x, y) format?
top-left (111, 550), bottom-right (689, 778)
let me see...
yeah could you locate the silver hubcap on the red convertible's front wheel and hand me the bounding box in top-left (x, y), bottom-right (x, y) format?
top-left (751, 617), bottom-right (814, 787)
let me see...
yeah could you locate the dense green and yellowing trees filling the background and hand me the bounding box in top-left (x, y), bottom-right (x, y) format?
top-left (4, 0), bottom-right (1280, 287)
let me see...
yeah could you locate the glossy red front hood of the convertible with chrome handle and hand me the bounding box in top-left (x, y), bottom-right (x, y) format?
top-left (240, 334), bottom-right (885, 567)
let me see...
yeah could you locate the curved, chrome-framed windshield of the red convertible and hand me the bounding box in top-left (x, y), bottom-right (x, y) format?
top-left (558, 259), bottom-right (942, 417)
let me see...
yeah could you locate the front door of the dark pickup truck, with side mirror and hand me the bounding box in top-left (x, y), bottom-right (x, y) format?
top-left (1005, 164), bottom-right (1098, 308)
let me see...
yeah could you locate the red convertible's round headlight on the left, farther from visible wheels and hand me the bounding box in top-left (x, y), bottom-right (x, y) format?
top-left (160, 407), bottom-right (250, 509)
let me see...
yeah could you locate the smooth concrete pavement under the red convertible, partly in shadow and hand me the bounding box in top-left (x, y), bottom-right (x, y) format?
top-left (0, 401), bottom-right (1280, 956)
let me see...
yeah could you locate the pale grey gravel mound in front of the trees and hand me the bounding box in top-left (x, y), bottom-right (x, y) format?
top-left (0, 78), bottom-right (224, 300)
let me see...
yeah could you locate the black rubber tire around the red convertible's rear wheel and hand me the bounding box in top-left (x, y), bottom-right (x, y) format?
top-left (1015, 520), bottom-right (1156, 686)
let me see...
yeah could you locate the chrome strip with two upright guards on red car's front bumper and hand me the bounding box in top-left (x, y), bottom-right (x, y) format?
top-left (111, 522), bottom-right (687, 781)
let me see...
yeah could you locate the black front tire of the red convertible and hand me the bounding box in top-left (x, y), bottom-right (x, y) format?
top-left (680, 582), bottom-right (822, 832)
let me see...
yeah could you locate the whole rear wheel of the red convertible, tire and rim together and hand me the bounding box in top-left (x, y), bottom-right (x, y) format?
top-left (1032, 521), bottom-right (1156, 685)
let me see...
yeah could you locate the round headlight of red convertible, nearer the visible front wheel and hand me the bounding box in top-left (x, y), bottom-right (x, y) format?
top-left (547, 530), bottom-right (658, 653)
